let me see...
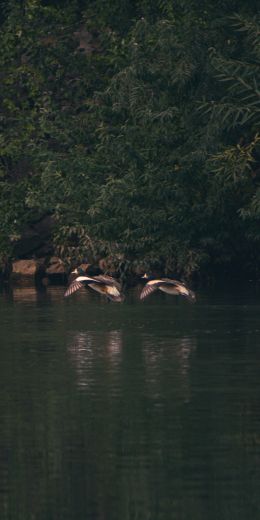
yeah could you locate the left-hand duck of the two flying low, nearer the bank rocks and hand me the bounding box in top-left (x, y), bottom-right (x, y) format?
top-left (64, 268), bottom-right (124, 302)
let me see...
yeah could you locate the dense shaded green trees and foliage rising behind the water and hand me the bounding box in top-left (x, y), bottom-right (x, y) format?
top-left (0, 0), bottom-right (260, 278)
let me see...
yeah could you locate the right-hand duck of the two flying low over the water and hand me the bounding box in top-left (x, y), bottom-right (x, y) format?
top-left (140, 274), bottom-right (196, 302)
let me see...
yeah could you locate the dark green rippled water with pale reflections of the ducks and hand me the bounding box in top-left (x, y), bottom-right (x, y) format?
top-left (0, 284), bottom-right (260, 520)
